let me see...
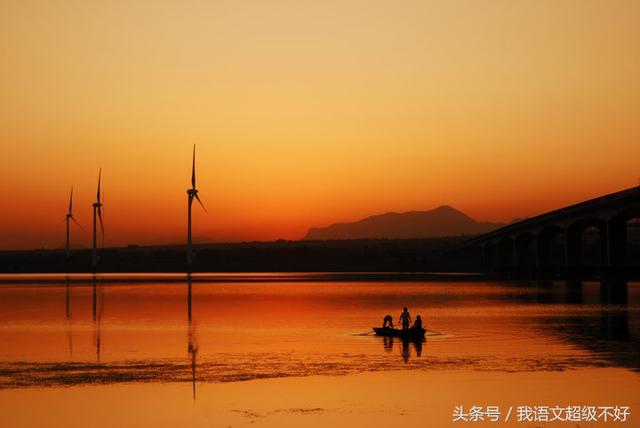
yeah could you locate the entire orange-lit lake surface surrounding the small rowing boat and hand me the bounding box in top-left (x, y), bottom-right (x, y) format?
top-left (0, 274), bottom-right (640, 427)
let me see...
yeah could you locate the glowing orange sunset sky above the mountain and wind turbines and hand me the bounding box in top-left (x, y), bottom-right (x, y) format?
top-left (0, 0), bottom-right (640, 249)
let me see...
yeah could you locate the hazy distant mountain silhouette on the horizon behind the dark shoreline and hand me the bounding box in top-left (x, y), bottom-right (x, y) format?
top-left (303, 205), bottom-right (504, 240)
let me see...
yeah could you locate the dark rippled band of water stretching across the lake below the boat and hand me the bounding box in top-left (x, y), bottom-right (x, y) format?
top-left (0, 354), bottom-right (609, 389)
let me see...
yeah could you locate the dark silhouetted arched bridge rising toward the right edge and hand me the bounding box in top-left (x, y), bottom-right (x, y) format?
top-left (455, 186), bottom-right (640, 269)
